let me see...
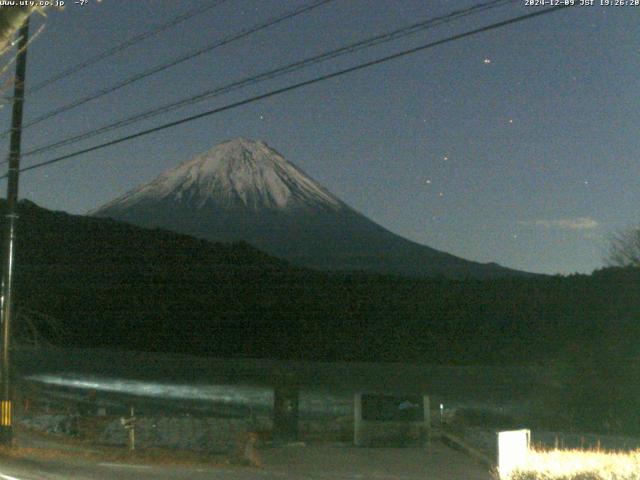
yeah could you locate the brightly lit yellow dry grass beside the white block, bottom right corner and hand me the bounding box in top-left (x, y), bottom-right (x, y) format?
top-left (509, 450), bottom-right (640, 480)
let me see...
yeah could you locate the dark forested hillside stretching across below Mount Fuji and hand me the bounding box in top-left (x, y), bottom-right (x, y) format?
top-left (2, 201), bottom-right (640, 364)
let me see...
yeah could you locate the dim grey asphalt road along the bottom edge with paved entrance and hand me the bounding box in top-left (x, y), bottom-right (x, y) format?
top-left (0, 443), bottom-right (492, 480)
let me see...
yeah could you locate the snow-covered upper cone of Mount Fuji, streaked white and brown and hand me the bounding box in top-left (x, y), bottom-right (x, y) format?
top-left (93, 138), bottom-right (343, 213)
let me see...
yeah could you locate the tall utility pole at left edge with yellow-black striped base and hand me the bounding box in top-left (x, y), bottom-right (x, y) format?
top-left (0, 18), bottom-right (29, 444)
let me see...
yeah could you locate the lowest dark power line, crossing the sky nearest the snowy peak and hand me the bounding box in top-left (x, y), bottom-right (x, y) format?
top-left (0, 5), bottom-right (572, 179)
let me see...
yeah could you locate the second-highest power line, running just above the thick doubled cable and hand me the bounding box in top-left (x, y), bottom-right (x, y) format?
top-left (7, 0), bottom-right (334, 138)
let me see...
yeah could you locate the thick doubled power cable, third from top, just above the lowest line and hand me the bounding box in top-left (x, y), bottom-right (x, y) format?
top-left (22, 0), bottom-right (518, 159)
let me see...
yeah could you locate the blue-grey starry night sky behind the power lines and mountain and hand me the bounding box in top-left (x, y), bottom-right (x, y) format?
top-left (0, 0), bottom-right (640, 274)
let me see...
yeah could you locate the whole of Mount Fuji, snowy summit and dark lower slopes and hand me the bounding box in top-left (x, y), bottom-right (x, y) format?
top-left (94, 138), bottom-right (524, 278)
